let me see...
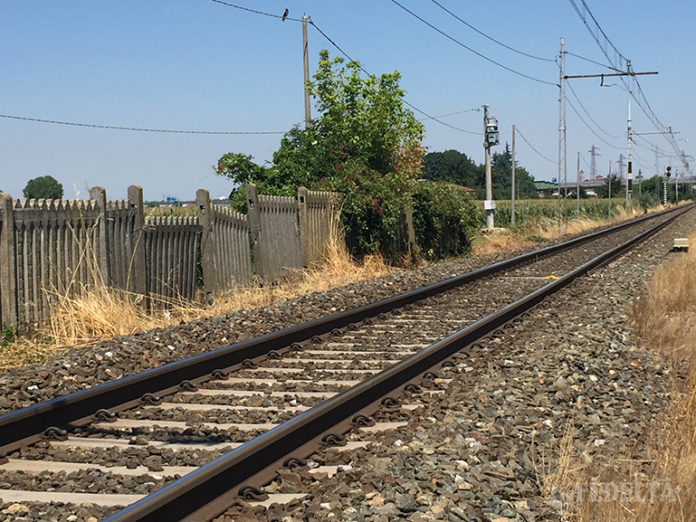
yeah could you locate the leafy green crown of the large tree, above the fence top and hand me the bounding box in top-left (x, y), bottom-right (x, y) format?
top-left (215, 50), bottom-right (423, 194)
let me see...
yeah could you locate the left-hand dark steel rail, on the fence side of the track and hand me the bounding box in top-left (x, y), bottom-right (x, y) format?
top-left (0, 203), bottom-right (679, 458)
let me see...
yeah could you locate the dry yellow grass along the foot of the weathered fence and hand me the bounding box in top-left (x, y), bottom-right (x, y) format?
top-left (0, 229), bottom-right (391, 370)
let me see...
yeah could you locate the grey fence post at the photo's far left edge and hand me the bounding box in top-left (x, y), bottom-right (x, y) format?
top-left (0, 192), bottom-right (18, 327)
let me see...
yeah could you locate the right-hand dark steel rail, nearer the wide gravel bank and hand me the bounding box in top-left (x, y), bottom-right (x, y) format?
top-left (106, 203), bottom-right (688, 522)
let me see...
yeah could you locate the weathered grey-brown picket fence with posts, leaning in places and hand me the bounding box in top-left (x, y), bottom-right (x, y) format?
top-left (0, 185), bottom-right (338, 329)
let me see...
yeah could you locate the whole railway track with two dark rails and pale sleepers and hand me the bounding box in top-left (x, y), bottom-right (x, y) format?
top-left (0, 205), bottom-right (685, 520)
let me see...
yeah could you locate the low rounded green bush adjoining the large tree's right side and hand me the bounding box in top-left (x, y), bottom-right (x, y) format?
top-left (413, 182), bottom-right (480, 259)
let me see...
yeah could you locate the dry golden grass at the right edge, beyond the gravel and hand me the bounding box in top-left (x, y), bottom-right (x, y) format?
top-left (542, 234), bottom-right (696, 522)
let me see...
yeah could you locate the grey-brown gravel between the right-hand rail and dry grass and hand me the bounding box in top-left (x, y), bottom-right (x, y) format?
top-left (219, 211), bottom-right (696, 522)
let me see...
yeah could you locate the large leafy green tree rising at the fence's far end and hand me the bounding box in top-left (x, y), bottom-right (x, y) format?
top-left (215, 50), bottom-right (423, 257)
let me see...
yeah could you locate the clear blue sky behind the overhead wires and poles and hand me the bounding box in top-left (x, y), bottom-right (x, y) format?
top-left (0, 0), bottom-right (696, 200)
